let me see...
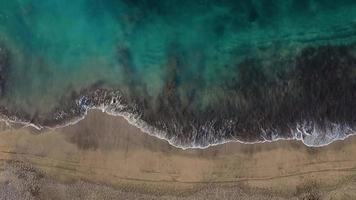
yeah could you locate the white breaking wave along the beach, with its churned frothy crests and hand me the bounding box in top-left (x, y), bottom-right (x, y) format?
top-left (1, 90), bottom-right (356, 150)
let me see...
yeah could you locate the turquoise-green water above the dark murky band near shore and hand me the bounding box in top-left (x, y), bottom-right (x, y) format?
top-left (0, 0), bottom-right (356, 147)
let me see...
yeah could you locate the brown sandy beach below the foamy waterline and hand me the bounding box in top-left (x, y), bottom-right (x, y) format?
top-left (0, 111), bottom-right (356, 199)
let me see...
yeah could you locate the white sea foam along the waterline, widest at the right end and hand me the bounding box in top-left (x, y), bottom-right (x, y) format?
top-left (1, 91), bottom-right (356, 150)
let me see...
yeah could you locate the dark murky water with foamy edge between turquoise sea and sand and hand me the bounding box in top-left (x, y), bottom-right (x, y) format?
top-left (0, 43), bottom-right (356, 149)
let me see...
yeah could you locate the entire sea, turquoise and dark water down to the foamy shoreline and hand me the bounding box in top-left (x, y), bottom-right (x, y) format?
top-left (0, 0), bottom-right (356, 147)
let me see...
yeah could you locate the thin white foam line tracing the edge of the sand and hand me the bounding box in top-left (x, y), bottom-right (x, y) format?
top-left (0, 105), bottom-right (356, 150)
